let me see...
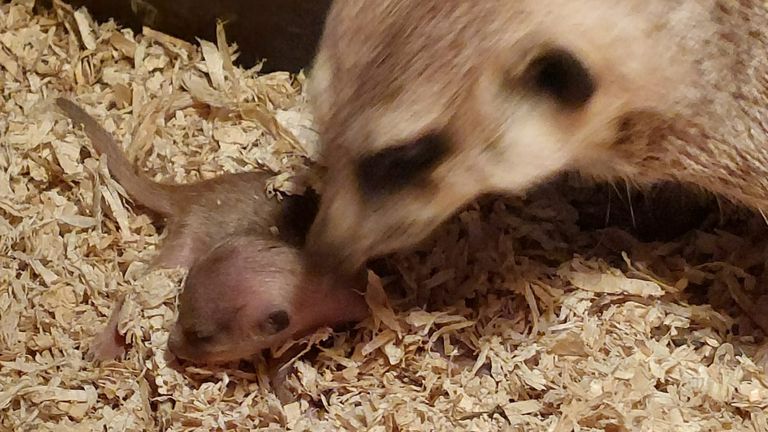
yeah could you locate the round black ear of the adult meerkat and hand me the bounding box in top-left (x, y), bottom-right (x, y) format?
top-left (526, 48), bottom-right (597, 109)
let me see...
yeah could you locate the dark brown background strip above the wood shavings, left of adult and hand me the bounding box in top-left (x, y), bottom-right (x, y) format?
top-left (42, 0), bottom-right (331, 72)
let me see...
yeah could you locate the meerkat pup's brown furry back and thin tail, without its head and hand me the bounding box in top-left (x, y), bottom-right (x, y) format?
top-left (56, 98), bottom-right (279, 268)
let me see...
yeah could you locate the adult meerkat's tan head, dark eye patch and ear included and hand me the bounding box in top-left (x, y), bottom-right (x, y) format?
top-left (308, 0), bottom-right (699, 269)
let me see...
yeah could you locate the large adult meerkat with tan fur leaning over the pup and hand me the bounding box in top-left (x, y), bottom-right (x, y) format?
top-left (308, 0), bottom-right (768, 269)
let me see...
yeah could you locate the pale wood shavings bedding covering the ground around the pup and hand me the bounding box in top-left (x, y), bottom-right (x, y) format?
top-left (0, 0), bottom-right (768, 432)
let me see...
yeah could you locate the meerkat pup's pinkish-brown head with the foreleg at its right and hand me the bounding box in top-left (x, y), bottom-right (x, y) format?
top-left (168, 236), bottom-right (367, 363)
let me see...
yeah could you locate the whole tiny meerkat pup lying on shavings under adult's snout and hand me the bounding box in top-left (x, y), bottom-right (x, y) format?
top-left (56, 98), bottom-right (367, 362)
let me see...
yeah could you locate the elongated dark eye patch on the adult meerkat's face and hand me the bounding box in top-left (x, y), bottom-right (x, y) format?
top-left (356, 133), bottom-right (449, 198)
